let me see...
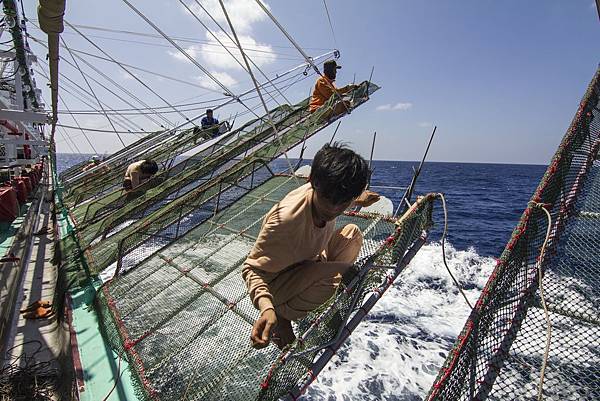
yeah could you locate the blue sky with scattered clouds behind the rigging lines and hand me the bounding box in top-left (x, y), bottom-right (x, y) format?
top-left (26, 0), bottom-right (600, 164)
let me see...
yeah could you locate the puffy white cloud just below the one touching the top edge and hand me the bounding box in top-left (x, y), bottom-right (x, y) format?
top-left (200, 32), bottom-right (277, 70)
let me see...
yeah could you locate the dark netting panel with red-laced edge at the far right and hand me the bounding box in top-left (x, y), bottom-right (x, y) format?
top-left (428, 70), bottom-right (600, 400)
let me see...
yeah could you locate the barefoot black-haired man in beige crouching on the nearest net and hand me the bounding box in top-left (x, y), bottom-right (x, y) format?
top-left (242, 144), bottom-right (379, 348)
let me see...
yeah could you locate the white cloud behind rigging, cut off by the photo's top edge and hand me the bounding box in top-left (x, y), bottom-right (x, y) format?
top-left (185, 0), bottom-right (269, 34)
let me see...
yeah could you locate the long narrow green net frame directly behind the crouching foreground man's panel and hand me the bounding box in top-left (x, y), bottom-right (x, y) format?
top-left (70, 81), bottom-right (379, 274)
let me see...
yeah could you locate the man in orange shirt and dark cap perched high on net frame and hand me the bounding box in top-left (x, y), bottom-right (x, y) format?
top-left (308, 60), bottom-right (357, 119)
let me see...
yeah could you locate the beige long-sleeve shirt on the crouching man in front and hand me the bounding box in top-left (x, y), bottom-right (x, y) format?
top-left (242, 183), bottom-right (335, 312)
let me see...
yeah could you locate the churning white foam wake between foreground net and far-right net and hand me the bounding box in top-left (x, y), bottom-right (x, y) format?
top-left (303, 243), bottom-right (495, 401)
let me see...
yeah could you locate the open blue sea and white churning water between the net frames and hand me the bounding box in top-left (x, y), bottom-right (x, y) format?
top-left (57, 154), bottom-right (545, 401)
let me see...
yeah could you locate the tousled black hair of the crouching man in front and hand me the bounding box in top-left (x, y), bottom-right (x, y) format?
top-left (310, 142), bottom-right (370, 205)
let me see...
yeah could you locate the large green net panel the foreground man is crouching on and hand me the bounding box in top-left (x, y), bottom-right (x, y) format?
top-left (97, 176), bottom-right (434, 400)
